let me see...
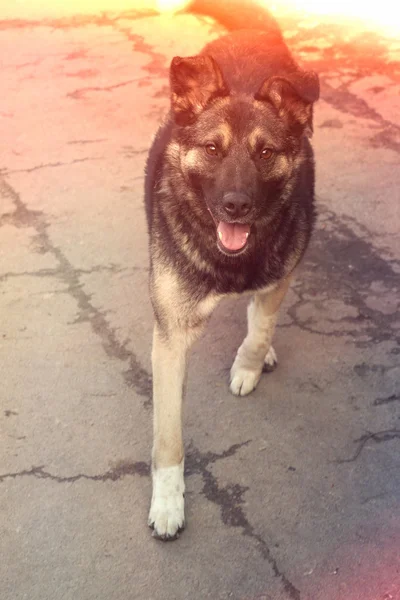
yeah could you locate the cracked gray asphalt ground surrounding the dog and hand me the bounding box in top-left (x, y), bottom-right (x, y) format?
top-left (0, 5), bottom-right (400, 600)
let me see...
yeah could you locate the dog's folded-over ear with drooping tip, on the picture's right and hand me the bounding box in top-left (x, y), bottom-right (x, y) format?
top-left (255, 69), bottom-right (319, 137)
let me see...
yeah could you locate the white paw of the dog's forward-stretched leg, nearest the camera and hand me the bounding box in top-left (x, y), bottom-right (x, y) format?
top-left (148, 461), bottom-right (185, 541)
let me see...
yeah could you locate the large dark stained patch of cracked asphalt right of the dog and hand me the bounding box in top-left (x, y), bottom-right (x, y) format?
top-left (280, 202), bottom-right (400, 348)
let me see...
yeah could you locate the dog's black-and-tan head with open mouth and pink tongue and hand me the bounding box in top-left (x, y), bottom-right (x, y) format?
top-left (170, 55), bottom-right (319, 254)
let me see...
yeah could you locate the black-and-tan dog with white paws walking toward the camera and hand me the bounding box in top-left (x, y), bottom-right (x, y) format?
top-left (145, 0), bottom-right (319, 541)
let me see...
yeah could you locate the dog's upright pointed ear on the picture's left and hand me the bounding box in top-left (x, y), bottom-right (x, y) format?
top-left (170, 55), bottom-right (229, 125)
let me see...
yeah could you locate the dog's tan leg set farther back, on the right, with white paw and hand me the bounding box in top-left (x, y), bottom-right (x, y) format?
top-left (230, 277), bottom-right (290, 396)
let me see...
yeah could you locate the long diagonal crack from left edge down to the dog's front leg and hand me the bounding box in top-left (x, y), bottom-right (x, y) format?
top-left (0, 178), bottom-right (152, 407)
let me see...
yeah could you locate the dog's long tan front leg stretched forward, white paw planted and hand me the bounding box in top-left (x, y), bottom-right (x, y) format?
top-left (149, 268), bottom-right (218, 540)
